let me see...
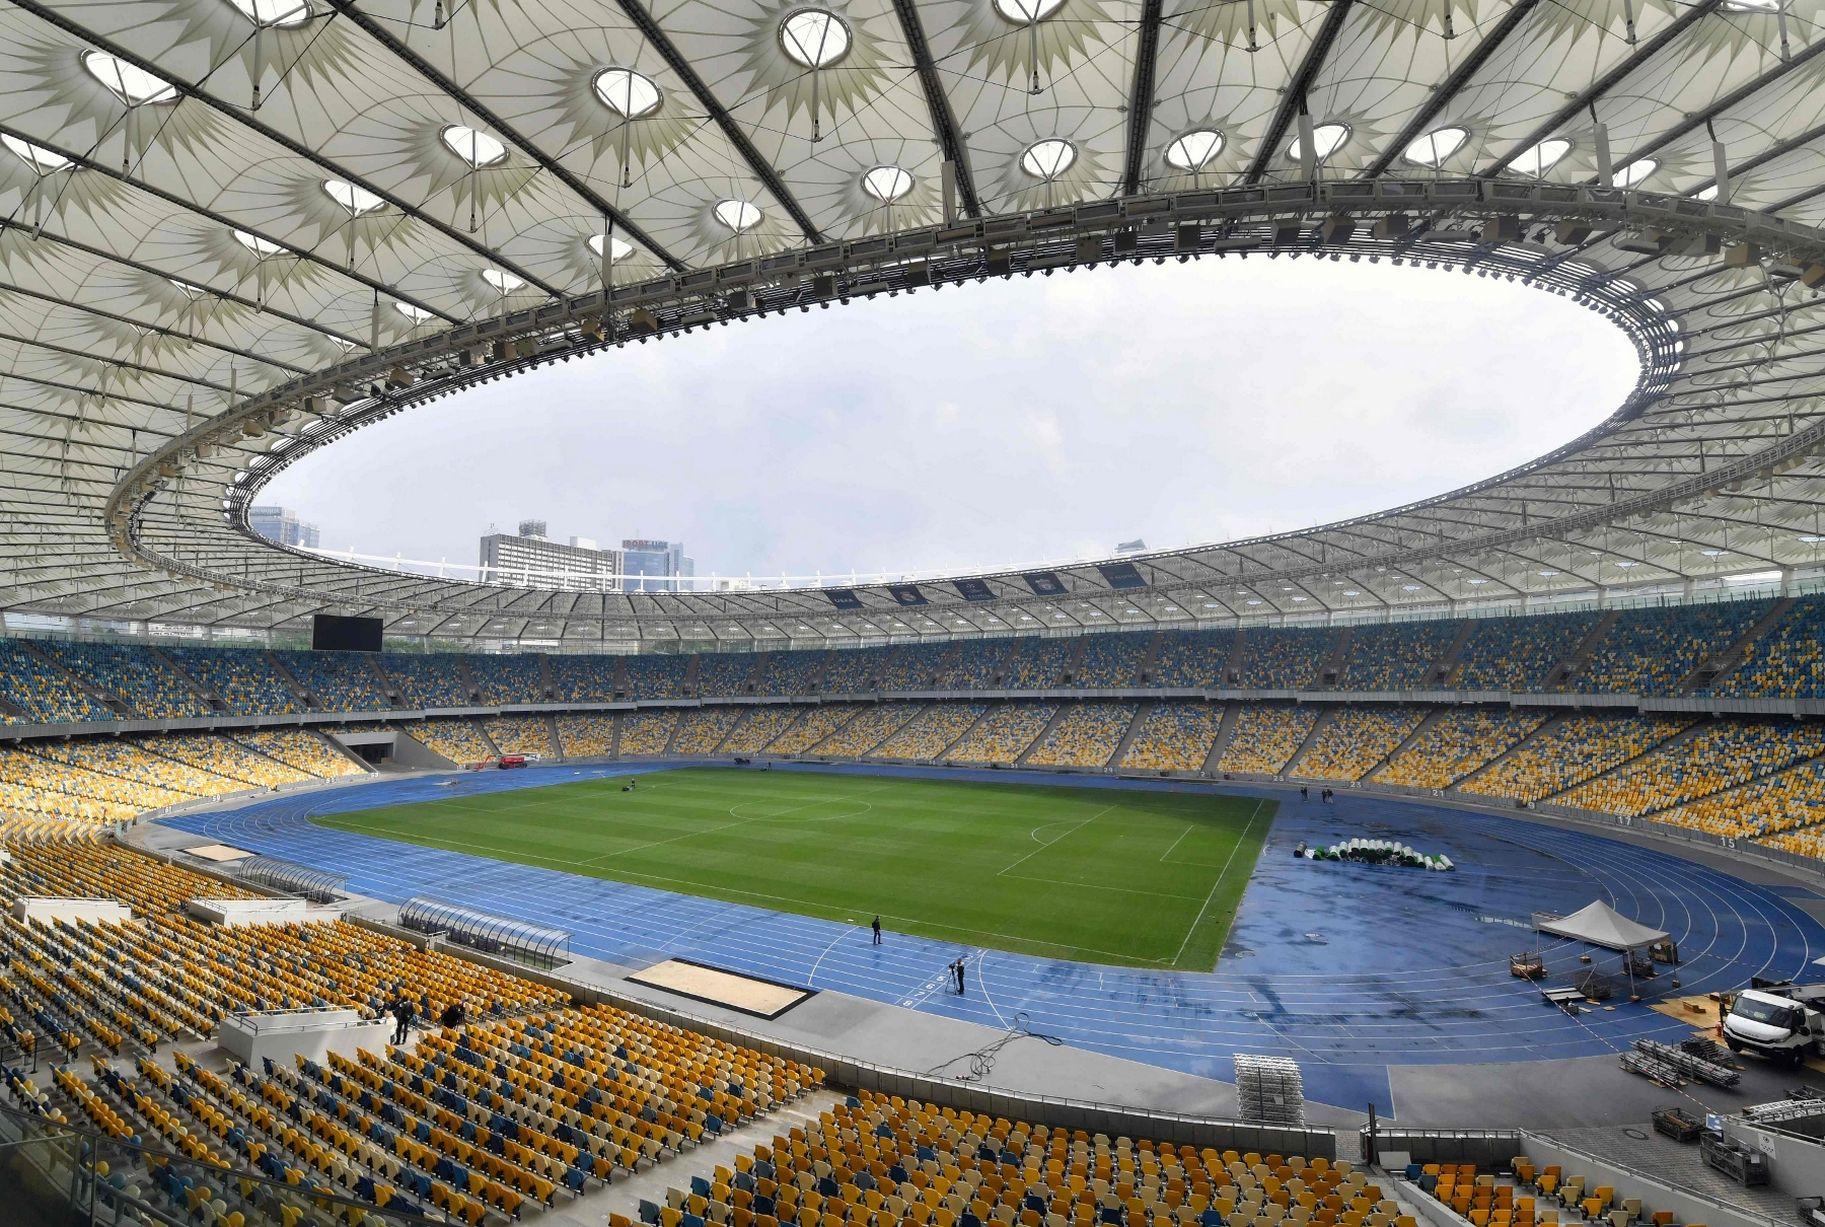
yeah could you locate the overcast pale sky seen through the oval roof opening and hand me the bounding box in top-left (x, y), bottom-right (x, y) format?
top-left (261, 257), bottom-right (1635, 575)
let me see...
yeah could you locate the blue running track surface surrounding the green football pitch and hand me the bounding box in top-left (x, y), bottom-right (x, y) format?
top-left (161, 763), bottom-right (1825, 1114)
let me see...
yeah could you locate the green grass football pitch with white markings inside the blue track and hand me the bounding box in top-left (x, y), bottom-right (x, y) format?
top-left (316, 767), bottom-right (1274, 971)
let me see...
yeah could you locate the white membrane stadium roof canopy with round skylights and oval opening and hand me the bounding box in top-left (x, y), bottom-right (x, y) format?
top-left (0, 0), bottom-right (1825, 643)
